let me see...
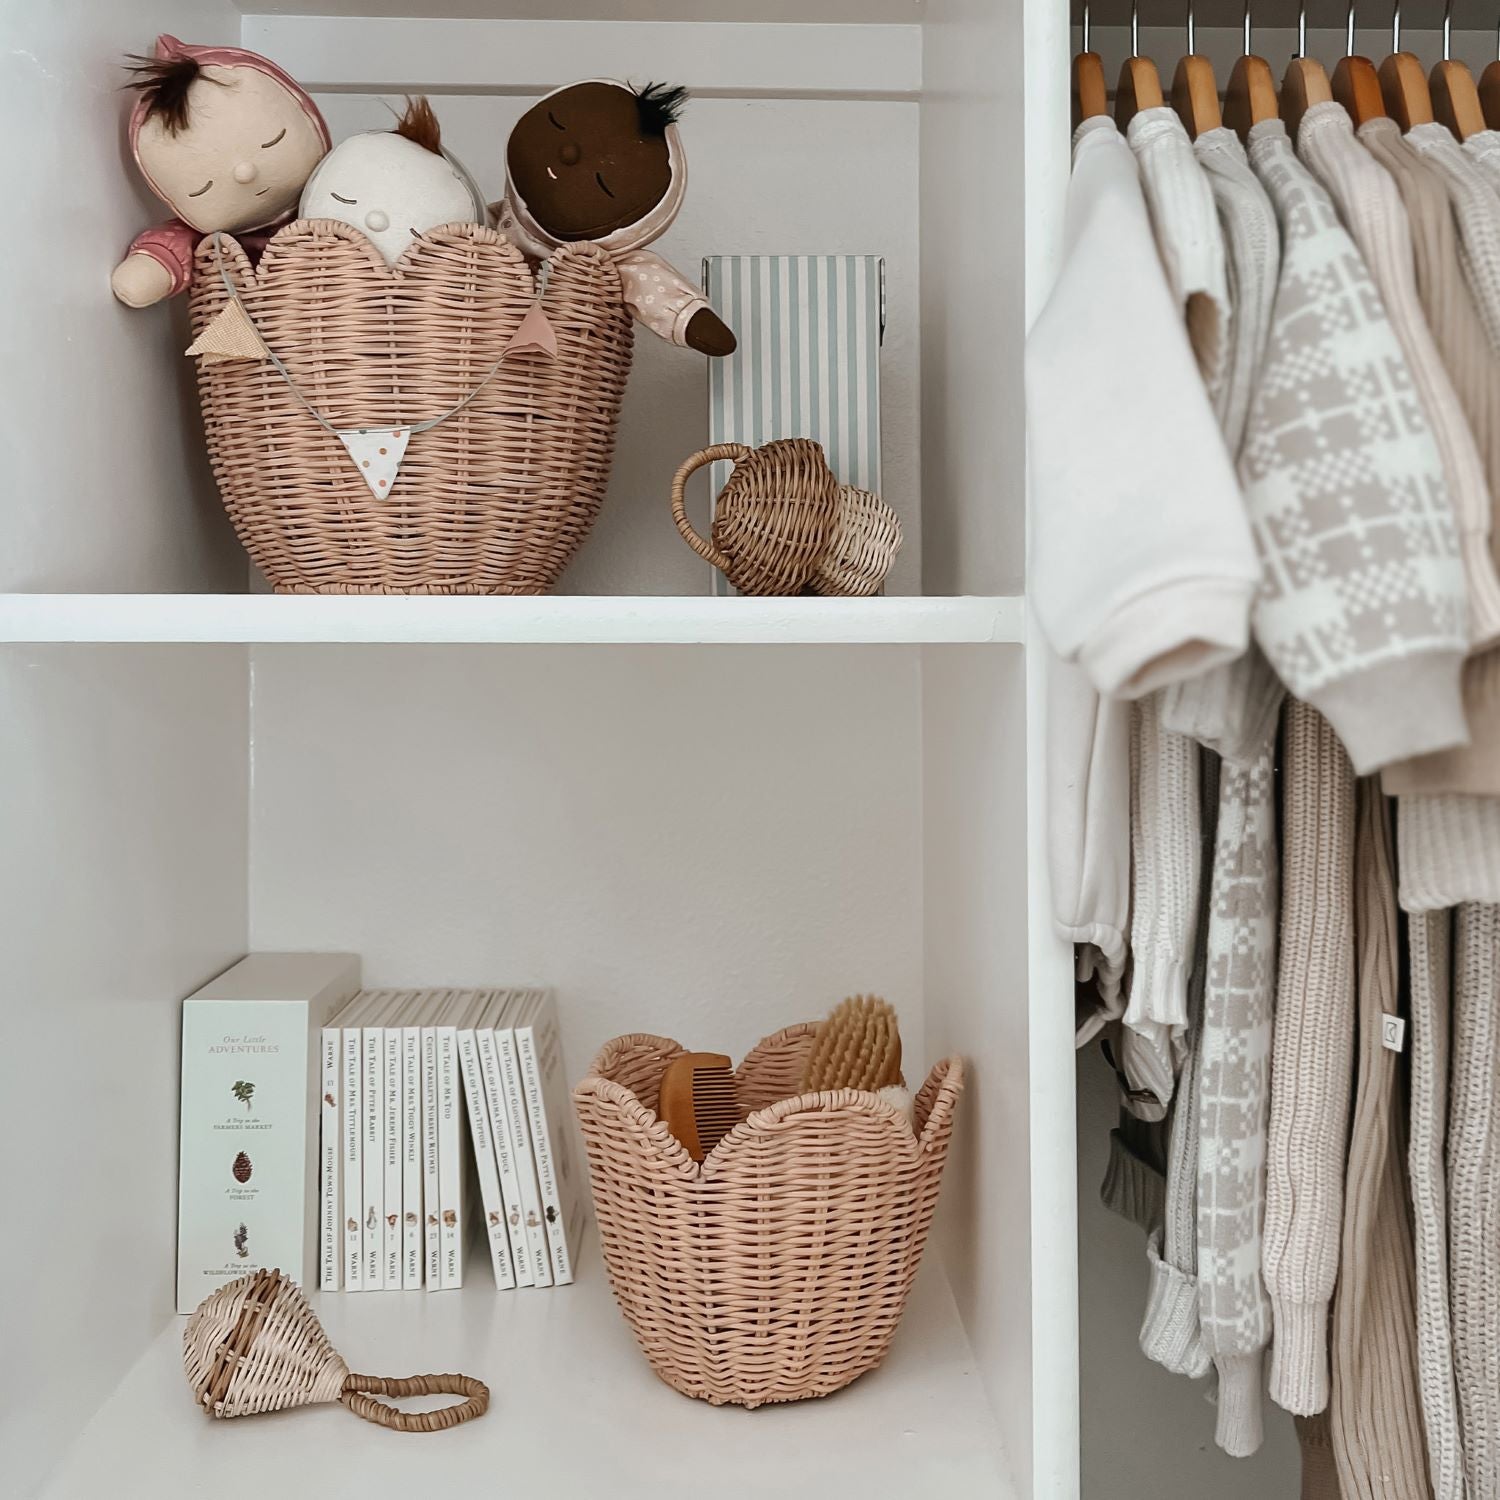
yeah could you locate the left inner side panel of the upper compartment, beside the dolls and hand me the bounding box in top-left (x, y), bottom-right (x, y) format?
top-left (0, 0), bottom-right (245, 591)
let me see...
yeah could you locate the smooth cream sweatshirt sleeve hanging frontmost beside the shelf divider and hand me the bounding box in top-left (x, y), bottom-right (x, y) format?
top-left (1026, 119), bottom-right (1260, 698)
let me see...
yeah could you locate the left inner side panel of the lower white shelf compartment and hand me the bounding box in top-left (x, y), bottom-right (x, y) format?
top-left (0, 647), bottom-right (249, 1494)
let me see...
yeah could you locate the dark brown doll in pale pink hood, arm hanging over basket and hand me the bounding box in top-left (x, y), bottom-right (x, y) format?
top-left (495, 78), bottom-right (735, 356)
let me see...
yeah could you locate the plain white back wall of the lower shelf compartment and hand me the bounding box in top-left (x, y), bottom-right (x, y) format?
top-left (251, 647), bottom-right (924, 1077)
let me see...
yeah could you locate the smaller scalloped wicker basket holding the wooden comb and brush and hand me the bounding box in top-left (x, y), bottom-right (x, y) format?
top-left (573, 1026), bottom-right (963, 1407)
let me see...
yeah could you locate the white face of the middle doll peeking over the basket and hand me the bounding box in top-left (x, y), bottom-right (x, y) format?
top-left (302, 131), bottom-right (482, 264)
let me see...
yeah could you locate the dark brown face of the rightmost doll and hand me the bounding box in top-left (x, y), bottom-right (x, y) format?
top-left (506, 84), bottom-right (672, 240)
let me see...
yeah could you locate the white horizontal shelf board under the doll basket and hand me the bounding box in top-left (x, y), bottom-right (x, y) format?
top-left (0, 594), bottom-right (1026, 645)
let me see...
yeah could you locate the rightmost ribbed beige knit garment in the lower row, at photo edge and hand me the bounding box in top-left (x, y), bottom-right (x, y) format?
top-left (1448, 906), bottom-right (1500, 1500)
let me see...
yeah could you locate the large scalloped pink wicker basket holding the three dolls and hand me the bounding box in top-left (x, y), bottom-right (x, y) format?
top-left (192, 219), bottom-right (633, 594)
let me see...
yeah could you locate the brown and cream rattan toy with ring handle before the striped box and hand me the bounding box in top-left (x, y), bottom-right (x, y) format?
top-left (672, 438), bottom-right (902, 594)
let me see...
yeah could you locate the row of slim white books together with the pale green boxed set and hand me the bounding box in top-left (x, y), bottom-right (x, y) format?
top-left (177, 954), bottom-right (584, 1313)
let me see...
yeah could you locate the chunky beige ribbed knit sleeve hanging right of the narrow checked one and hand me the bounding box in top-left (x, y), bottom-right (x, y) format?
top-left (1263, 701), bottom-right (1355, 1416)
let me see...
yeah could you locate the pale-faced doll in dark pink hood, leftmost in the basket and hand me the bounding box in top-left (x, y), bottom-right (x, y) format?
top-left (110, 36), bottom-right (330, 308)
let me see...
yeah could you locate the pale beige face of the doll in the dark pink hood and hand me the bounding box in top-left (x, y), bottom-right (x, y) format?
top-left (137, 65), bottom-right (323, 233)
